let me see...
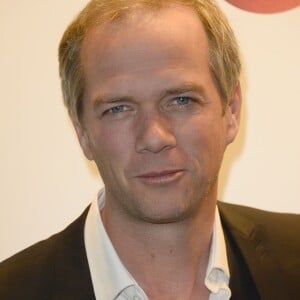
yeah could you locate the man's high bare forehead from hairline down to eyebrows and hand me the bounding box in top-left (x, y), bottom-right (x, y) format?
top-left (81, 2), bottom-right (218, 106)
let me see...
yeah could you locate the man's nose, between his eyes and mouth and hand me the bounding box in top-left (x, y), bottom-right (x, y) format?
top-left (136, 113), bottom-right (176, 153)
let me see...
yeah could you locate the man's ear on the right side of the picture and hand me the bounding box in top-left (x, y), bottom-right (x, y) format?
top-left (225, 82), bottom-right (242, 145)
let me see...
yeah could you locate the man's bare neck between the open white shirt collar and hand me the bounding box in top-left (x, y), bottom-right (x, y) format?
top-left (102, 193), bottom-right (215, 299)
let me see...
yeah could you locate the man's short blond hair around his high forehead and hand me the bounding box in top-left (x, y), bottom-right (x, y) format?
top-left (59, 0), bottom-right (241, 122)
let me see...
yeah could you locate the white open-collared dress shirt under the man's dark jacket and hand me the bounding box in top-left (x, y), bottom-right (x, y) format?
top-left (84, 190), bottom-right (231, 300)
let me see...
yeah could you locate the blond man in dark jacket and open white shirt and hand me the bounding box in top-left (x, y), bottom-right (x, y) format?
top-left (0, 0), bottom-right (300, 300)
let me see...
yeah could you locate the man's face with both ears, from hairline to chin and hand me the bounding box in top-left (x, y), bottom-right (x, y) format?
top-left (75, 5), bottom-right (239, 223)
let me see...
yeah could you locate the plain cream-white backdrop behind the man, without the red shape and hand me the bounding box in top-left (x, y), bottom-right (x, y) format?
top-left (0, 0), bottom-right (300, 261)
